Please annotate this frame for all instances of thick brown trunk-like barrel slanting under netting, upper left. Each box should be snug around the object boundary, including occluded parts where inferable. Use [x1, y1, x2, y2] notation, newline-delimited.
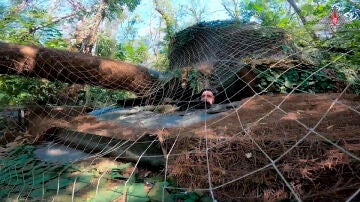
[0, 42, 158, 96]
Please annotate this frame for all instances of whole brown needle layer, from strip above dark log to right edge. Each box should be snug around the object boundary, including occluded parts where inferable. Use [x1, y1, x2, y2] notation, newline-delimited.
[5, 94, 360, 201]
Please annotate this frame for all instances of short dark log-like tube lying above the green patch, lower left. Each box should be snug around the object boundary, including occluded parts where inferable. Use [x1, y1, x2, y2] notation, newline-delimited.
[46, 127, 165, 168]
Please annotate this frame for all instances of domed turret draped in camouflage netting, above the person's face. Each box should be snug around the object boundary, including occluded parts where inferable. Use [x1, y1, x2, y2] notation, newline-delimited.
[169, 21, 301, 93]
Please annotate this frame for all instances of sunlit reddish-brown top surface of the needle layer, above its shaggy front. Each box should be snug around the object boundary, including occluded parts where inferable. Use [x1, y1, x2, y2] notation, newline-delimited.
[23, 94, 360, 138]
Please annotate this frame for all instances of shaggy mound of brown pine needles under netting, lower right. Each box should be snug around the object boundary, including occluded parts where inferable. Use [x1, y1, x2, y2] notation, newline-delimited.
[167, 94, 360, 201]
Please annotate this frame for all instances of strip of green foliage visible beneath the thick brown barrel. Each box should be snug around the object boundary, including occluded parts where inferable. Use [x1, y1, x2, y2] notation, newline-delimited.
[0, 75, 133, 107]
